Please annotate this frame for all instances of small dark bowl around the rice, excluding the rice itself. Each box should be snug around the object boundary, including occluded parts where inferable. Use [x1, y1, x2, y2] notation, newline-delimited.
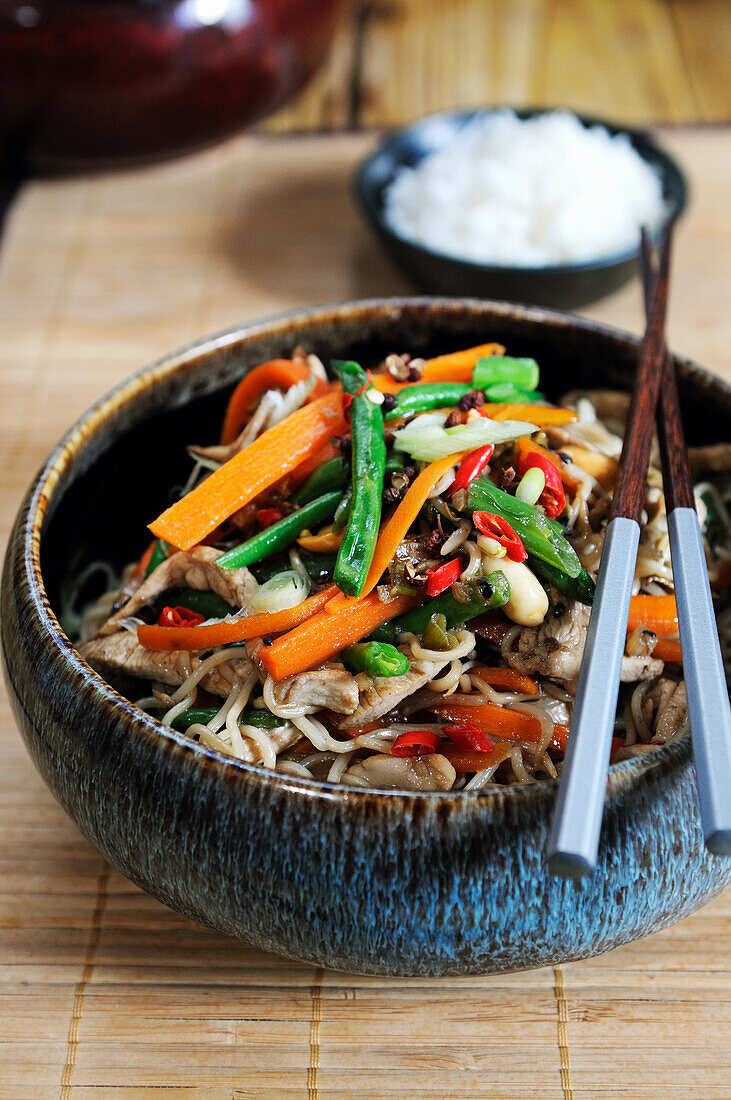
[355, 109, 688, 309]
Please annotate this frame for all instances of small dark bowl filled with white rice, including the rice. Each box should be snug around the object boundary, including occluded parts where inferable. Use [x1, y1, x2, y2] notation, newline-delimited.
[356, 108, 687, 309]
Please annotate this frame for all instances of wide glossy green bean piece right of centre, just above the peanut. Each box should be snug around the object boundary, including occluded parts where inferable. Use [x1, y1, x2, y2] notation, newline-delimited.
[467, 476, 582, 576]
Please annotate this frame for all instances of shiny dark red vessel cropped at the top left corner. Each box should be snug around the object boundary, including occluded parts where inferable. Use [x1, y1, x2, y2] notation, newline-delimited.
[0, 0, 344, 172]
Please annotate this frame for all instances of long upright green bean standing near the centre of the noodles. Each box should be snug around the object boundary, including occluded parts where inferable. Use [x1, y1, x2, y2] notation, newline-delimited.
[332, 361, 386, 596]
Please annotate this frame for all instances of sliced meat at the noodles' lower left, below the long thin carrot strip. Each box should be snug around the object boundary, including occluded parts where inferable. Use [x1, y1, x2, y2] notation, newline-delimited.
[79, 630, 251, 697]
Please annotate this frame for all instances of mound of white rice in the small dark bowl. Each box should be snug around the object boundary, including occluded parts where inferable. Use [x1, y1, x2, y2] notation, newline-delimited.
[385, 110, 665, 267]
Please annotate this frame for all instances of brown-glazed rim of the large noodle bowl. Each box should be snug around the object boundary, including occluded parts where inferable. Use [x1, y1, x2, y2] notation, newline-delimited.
[14, 297, 707, 812]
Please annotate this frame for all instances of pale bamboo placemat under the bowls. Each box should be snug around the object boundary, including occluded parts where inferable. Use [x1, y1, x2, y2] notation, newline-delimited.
[0, 130, 731, 1100]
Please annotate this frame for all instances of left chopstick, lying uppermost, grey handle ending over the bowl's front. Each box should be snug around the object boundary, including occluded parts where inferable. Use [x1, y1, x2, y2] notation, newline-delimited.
[547, 223, 673, 878]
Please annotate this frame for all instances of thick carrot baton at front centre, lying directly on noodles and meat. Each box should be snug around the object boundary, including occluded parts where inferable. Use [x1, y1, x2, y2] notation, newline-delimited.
[259, 592, 420, 680]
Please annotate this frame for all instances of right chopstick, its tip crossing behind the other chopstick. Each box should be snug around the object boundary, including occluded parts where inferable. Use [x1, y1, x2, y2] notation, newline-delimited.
[641, 230, 731, 856]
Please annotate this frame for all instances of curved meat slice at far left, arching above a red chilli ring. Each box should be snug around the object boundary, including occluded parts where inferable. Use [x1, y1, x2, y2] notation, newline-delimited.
[99, 547, 256, 636]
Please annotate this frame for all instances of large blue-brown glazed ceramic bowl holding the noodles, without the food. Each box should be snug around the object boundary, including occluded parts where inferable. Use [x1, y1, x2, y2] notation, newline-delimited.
[2, 299, 731, 975]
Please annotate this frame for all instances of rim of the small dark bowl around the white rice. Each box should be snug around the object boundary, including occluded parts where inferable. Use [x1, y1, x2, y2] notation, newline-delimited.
[353, 105, 689, 277]
